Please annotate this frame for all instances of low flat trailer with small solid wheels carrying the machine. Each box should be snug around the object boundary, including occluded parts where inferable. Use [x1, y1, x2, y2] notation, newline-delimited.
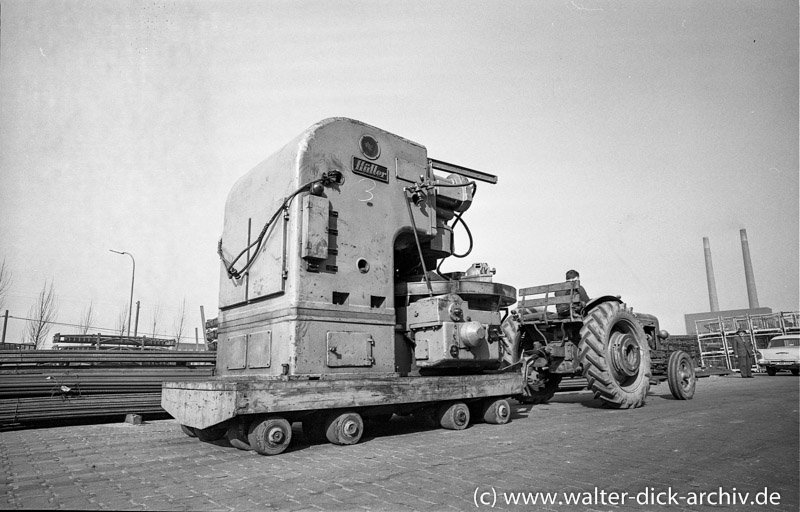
[162, 372, 523, 455]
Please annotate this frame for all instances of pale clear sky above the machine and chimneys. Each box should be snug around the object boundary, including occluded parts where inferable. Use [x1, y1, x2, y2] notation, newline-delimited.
[0, 0, 800, 341]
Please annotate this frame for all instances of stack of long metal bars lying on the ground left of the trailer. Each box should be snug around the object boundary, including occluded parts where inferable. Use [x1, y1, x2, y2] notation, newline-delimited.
[0, 350, 216, 428]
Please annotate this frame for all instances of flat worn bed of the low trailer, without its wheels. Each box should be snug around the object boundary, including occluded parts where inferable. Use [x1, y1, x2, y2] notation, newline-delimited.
[161, 368, 524, 429]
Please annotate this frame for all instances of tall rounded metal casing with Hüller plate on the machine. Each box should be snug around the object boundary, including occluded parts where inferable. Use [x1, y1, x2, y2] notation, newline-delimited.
[212, 118, 500, 376]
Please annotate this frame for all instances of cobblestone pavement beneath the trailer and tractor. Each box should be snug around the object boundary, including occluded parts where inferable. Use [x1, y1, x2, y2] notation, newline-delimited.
[0, 374, 800, 511]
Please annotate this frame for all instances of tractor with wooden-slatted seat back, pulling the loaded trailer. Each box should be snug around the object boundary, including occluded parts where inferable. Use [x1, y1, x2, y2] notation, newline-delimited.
[502, 280, 696, 409]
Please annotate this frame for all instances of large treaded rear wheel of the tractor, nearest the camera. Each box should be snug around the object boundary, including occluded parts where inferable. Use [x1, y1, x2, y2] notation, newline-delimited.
[580, 302, 652, 409]
